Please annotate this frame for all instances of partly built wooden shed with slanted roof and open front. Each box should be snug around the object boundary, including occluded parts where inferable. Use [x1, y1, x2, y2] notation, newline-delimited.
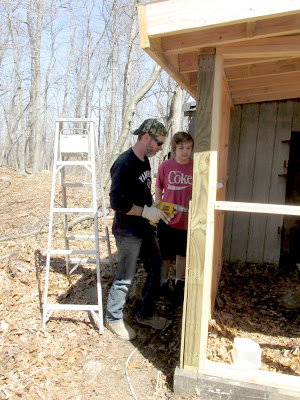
[138, 0, 300, 399]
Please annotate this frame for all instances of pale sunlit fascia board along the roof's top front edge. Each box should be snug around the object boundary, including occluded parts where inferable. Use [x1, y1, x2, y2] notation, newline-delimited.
[142, 0, 300, 36]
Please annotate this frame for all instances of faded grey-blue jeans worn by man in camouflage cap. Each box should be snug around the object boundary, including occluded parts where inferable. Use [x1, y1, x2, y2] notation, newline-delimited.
[105, 232, 162, 322]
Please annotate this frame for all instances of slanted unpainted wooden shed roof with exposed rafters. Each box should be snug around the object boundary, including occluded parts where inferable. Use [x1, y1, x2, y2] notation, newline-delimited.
[138, 0, 300, 104]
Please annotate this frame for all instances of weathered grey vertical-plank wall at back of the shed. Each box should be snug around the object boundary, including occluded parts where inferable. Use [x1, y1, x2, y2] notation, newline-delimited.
[223, 100, 300, 264]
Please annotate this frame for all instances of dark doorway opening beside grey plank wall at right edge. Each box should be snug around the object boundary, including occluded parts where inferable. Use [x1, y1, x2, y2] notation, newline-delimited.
[281, 132, 300, 265]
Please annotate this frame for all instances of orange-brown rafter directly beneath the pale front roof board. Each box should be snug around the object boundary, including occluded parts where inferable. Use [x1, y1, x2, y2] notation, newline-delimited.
[161, 14, 300, 54]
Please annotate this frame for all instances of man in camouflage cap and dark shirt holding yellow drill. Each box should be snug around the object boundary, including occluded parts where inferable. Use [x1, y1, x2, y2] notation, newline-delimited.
[105, 119, 170, 340]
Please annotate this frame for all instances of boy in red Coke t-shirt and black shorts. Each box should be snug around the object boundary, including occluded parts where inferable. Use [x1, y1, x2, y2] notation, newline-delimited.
[155, 131, 194, 303]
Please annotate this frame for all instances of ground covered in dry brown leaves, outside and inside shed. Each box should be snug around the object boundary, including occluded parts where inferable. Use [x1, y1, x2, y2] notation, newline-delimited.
[0, 167, 300, 400]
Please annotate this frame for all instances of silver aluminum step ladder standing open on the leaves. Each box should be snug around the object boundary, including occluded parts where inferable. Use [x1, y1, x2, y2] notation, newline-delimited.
[42, 118, 113, 333]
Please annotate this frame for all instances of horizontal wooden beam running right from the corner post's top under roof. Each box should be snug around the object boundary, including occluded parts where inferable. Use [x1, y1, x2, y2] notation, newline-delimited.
[217, 35, 300, 58]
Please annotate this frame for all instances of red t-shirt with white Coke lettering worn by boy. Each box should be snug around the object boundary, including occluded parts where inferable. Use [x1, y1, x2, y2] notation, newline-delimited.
[155, 158, 193, 229]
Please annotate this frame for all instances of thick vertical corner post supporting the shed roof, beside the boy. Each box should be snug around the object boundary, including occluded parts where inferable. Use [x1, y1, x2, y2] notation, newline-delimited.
[180, 54, 223, 368]
